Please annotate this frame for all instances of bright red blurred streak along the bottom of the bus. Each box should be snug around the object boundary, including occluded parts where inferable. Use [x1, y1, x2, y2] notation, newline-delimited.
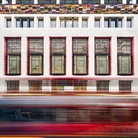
[0, 122, 138, 136]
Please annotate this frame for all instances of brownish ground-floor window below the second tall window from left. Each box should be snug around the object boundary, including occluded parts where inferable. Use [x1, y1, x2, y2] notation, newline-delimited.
[29, 81, 42, 92]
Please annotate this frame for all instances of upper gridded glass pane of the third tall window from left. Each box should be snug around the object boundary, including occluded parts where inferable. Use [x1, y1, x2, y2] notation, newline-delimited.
[51, 38, 65, 54]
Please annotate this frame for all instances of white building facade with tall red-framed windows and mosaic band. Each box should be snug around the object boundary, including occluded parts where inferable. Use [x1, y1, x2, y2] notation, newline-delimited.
[0, 0, 138, 94]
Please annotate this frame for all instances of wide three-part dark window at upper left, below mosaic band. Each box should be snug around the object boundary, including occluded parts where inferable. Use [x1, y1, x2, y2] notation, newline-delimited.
[16, 17, 34, 28]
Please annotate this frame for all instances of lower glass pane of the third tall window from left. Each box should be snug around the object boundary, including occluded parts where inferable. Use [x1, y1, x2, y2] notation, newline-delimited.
[52, 55, 65, 74]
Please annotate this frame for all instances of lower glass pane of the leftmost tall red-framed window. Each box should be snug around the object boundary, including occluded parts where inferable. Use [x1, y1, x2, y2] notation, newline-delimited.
[7, 56, 20, 74]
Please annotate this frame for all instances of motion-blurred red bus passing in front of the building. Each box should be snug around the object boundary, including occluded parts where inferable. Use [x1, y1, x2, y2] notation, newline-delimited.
[0, 96, 138, 137]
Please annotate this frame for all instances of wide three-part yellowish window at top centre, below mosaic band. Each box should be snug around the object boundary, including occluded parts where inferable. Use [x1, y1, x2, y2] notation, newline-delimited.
[60, 17, 78, 28]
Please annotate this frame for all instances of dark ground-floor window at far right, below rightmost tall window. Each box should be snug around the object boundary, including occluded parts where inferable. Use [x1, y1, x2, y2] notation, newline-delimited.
[119, 81, 132, 92]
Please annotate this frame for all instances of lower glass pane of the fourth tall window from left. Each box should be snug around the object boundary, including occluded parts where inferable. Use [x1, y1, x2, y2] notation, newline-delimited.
[73, 55, 87, 74]
